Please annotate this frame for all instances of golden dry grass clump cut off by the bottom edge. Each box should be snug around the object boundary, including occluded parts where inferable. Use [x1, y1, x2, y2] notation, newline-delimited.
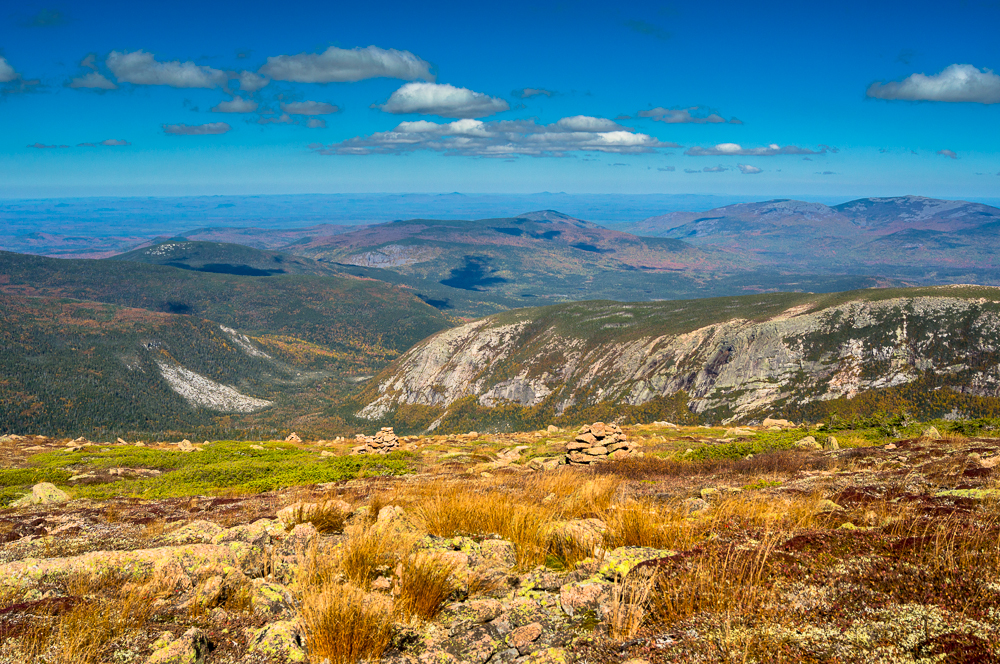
[302, 583, 393, 664]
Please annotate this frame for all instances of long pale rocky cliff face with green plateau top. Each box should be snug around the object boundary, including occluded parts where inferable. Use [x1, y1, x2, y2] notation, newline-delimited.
[358, 287, 1000, 419]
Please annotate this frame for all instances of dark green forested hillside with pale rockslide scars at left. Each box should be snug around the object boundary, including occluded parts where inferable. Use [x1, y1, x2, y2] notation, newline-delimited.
[0, 248, 452, 436]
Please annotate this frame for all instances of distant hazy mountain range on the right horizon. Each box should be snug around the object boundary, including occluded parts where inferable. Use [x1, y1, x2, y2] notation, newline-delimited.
[626, 196, 1000, 284]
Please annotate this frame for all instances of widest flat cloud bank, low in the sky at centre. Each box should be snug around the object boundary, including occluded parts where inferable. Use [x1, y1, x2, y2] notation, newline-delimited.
[317, 115, 680, 157]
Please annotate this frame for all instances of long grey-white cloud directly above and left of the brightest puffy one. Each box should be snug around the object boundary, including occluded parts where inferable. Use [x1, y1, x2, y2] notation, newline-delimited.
[258, 46, 434, 83]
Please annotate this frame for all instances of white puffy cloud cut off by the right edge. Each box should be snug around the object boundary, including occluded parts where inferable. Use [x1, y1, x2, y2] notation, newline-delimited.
[867, 65, 1000, 104]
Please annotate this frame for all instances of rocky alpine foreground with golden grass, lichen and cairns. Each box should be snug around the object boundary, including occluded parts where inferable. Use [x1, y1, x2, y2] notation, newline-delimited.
[0, 420, 1000, 664]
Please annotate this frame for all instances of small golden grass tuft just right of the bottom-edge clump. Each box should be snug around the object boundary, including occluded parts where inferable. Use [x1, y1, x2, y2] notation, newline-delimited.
[394, 552, 457, 620]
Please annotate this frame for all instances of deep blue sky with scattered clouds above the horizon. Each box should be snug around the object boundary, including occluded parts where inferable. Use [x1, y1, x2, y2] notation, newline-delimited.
[0, 0, 1000, 198]
